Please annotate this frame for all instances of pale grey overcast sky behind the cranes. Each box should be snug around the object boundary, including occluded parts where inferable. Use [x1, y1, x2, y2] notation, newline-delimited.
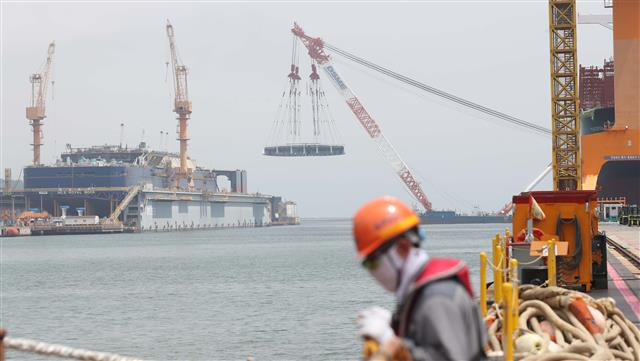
[0, 0, 613, 217]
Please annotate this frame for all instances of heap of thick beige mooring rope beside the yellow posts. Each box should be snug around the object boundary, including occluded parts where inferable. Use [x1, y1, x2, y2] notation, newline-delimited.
[485, 285, 640, 361]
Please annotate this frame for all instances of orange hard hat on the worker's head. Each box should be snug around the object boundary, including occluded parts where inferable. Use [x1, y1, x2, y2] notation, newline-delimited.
[353, 196, 420, 258]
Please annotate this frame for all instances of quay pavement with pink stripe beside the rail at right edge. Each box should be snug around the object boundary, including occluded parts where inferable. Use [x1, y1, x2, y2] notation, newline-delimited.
[591, 224, 640, 327]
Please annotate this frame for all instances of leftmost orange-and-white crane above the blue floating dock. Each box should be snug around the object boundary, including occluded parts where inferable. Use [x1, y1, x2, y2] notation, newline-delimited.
[27, 42, 56, 165]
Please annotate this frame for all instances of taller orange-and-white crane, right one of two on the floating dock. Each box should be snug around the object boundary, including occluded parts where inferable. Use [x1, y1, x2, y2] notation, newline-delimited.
[167, 20, 192, 186]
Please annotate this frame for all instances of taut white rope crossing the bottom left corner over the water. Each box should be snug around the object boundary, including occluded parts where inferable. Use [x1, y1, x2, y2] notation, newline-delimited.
[3, 337, 142, 361]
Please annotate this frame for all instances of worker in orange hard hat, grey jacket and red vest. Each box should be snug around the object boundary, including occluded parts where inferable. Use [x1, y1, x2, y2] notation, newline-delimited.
[353, 197, 486, 361]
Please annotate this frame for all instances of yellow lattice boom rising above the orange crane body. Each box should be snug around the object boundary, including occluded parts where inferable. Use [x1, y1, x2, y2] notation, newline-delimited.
[549, 0, 582, 191]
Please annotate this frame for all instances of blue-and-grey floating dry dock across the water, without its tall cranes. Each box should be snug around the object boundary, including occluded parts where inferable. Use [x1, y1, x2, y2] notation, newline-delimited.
[0, 143, 298, 234]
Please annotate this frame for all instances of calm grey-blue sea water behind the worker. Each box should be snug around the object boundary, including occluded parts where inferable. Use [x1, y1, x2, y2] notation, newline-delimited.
[0, 220, 506, 361]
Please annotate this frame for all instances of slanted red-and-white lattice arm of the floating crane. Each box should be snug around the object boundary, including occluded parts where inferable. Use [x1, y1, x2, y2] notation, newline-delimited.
[291, 24, 431, 211]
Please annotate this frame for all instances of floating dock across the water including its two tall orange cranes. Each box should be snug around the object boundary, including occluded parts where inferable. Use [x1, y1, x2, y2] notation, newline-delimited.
[0, 22, 299, 236]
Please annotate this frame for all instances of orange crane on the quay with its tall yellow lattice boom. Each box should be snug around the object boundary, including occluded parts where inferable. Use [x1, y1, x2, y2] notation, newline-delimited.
[505, 0, 607, 291]
